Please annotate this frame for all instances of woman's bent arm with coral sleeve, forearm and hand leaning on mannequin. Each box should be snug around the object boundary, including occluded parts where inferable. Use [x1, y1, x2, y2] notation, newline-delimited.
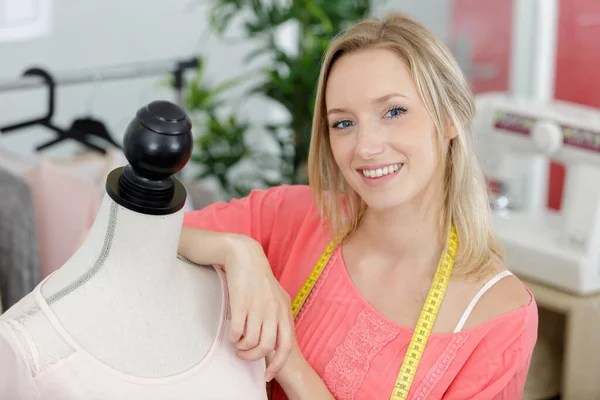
[178, 186, 312, 379]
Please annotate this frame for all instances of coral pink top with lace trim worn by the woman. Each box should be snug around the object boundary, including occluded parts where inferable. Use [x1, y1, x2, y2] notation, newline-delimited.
[184, 186, 538, 400]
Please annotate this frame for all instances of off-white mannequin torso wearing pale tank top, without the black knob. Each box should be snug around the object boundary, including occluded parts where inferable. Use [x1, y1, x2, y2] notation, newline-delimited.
[0, 196, 266, 400]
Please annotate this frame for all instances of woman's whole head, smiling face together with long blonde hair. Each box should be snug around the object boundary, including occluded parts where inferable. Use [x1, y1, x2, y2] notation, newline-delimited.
[308, 13, 503, 274]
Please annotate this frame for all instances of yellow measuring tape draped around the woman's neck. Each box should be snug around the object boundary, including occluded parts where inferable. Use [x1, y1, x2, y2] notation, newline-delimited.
[267, 224, 458, 400]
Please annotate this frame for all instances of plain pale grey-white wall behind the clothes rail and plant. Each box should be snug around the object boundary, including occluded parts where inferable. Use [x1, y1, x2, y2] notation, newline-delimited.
[0, 0, 450, 177]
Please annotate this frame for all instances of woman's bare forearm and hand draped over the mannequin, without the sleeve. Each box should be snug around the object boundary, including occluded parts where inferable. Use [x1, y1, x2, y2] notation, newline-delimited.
[178, 227, 294, 380]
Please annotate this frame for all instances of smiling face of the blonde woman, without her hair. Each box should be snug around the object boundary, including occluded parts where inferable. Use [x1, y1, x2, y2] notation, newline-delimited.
[325, 49, 442, 210]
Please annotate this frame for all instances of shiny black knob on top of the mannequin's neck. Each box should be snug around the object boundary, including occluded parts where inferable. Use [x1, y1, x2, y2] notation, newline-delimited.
[106, 101, 193, 215]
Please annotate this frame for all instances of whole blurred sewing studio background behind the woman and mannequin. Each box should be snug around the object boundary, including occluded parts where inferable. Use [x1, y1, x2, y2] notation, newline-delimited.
[0, 0, 600, 400]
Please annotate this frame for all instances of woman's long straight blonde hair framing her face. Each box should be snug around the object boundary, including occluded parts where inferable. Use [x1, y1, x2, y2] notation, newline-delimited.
[308, 13, 503, 275]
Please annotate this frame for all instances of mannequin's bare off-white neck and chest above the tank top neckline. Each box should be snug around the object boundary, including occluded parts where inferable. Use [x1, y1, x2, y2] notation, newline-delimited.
[41, 192, 223, 377]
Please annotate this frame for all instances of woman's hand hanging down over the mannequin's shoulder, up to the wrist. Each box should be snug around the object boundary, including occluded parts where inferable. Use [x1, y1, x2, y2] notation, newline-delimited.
[224, 236, 294, 381]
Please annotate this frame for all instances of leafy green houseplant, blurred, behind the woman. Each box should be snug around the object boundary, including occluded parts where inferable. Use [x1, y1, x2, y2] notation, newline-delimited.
[185, 0, 371, 199]
